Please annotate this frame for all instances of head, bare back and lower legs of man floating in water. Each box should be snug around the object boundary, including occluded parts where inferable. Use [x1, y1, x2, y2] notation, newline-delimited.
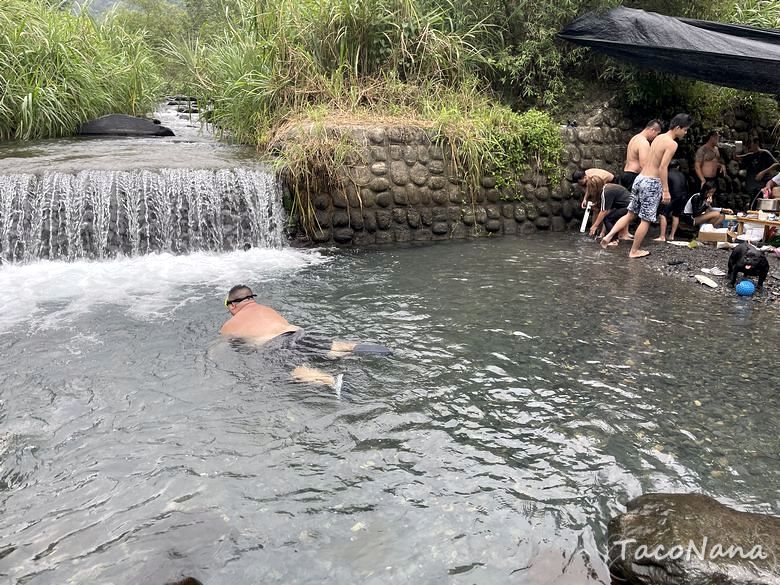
[219, 284, 391, 387]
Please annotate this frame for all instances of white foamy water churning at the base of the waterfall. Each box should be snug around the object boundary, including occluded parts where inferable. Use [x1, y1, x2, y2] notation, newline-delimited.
[0, 248, 329, 333]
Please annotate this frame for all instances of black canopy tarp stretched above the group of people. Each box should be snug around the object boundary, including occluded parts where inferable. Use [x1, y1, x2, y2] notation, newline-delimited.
[558, 7, 780, 95]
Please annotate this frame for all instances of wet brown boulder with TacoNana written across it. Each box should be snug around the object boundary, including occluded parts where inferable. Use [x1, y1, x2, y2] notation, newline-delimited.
[608, 494, 780, 585]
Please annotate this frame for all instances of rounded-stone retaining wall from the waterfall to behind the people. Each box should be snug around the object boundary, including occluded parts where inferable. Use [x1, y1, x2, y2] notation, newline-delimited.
[284, 108, 768, 246]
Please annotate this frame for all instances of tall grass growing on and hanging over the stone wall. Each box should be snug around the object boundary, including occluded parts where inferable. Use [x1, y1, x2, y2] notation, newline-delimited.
[169, 0, 562, 230]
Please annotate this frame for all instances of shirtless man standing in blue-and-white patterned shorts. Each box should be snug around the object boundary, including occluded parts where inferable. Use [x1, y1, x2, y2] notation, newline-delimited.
[601, 114, 693, 258]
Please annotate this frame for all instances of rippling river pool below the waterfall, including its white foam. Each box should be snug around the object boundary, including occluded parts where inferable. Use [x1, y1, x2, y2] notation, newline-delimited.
[0, 234, 780, 585]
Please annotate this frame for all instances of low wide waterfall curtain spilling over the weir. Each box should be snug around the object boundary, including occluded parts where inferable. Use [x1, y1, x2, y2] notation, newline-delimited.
[0, 169, 284, 262]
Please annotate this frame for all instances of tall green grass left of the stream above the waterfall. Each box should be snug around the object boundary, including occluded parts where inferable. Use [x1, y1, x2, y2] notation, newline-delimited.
[0, 0, 161, 140]
